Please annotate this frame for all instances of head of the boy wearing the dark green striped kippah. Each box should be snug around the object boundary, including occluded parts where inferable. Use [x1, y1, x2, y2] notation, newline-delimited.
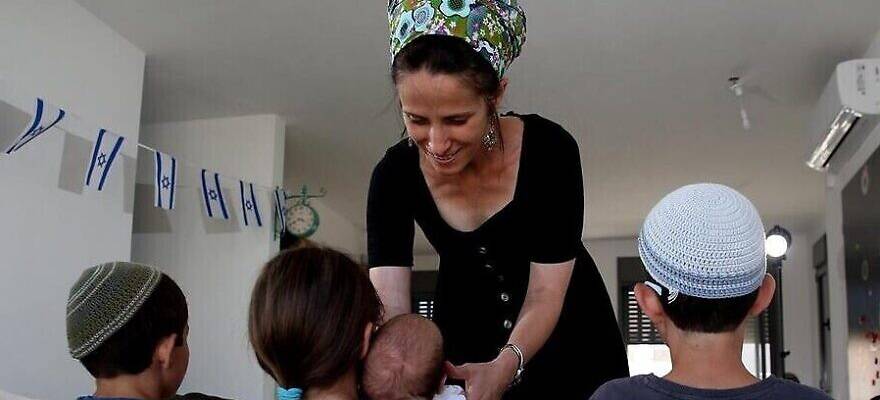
[66, 262, 189, 400]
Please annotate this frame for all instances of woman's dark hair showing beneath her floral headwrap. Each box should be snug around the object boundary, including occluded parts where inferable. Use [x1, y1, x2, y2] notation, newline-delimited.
[391, 35, 501, 99]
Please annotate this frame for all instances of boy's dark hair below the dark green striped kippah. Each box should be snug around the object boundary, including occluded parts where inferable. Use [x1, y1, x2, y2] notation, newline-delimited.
[80, 274, 189, 379]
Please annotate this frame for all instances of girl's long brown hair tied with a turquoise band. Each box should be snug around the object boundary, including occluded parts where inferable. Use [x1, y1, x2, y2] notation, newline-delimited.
[248, 246, 382, 389]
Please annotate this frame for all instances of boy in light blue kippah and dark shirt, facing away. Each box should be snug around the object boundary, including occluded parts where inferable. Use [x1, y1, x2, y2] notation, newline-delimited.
[591, 183, 830, 400]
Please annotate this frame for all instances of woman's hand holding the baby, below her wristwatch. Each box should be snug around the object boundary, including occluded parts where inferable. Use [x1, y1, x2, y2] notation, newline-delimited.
[446, 351, 519, 400]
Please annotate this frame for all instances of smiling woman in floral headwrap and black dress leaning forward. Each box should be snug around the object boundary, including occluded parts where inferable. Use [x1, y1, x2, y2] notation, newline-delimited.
[367, 0, 628, 400]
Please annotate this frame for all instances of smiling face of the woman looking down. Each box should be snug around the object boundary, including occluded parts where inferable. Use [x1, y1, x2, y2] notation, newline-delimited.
[397, 70, 489, 175]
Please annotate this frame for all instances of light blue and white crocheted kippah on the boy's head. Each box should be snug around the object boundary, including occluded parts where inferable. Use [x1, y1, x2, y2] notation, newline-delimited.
[639, 183, 767, 301]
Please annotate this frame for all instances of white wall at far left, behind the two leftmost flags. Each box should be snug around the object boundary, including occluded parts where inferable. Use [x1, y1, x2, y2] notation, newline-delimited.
[0, 0, 144, 399]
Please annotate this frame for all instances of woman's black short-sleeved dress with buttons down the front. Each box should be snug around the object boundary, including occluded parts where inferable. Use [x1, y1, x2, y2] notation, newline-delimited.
[367, 115, 628, 399]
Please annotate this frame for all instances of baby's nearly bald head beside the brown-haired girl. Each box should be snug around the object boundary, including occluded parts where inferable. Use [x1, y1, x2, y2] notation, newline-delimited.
[363, 314, 444, 400]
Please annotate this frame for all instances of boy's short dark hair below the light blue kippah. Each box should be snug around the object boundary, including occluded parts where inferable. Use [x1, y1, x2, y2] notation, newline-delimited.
[660, 290, 758, 333]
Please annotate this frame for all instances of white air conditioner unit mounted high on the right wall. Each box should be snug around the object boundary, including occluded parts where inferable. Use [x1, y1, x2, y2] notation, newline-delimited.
[807, 58, 880, 171]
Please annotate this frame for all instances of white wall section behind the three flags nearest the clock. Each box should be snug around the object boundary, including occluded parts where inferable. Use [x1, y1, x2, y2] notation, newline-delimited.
[132, 115, 284, 399]
